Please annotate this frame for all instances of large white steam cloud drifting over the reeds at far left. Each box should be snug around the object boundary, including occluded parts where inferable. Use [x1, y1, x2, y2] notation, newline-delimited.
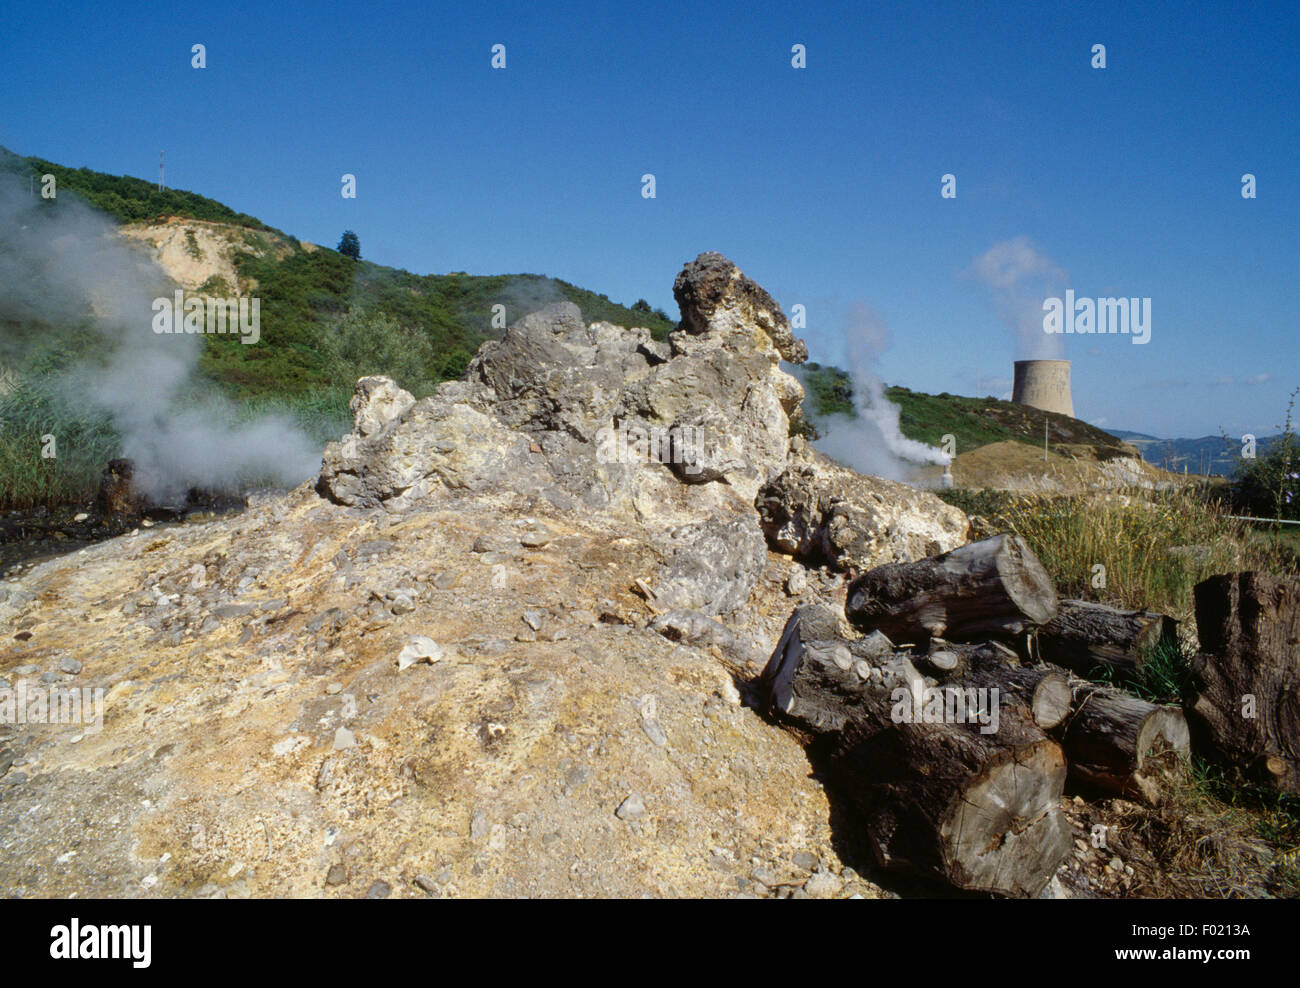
[0, 169, 320, 501]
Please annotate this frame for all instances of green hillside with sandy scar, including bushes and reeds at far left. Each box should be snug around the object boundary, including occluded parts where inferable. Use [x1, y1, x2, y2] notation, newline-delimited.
[0, 148, 675, 508]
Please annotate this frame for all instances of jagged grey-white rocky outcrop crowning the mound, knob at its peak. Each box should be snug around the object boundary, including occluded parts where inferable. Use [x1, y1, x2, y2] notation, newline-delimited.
[319, 255, 806, 511]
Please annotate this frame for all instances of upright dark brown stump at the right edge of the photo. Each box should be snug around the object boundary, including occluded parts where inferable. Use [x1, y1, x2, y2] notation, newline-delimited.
[1187, 573, 1300, 794]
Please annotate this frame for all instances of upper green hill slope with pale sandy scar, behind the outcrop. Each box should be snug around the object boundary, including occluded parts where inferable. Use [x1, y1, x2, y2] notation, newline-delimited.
[0, 148, 675, 398]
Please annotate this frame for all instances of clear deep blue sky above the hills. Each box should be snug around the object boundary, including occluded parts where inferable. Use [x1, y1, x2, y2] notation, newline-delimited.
[0, 0, 1300, 436]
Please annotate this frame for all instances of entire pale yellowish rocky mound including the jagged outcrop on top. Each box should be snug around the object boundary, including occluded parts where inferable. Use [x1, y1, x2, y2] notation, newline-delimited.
[0, 255, 1170, 898]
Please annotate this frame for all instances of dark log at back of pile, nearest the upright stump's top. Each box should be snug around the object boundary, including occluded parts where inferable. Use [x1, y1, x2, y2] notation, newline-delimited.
[1037, 601, 1178, 676]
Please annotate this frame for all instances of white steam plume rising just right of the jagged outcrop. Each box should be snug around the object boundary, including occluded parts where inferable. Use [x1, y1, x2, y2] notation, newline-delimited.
[795, 303, 950, 482]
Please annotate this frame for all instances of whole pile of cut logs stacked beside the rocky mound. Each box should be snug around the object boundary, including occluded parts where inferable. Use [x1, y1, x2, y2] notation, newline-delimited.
[762, 534, 1188, 896]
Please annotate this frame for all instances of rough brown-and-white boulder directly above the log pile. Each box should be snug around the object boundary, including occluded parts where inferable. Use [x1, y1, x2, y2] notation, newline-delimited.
[755, 439, 970, 569]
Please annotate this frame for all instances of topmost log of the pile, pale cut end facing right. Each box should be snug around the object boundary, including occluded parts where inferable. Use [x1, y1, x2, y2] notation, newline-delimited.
[845, 533, 1057, 645]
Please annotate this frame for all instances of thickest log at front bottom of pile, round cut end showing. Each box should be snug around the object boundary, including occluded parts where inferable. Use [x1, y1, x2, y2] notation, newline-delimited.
[831, 711, 1071, 896]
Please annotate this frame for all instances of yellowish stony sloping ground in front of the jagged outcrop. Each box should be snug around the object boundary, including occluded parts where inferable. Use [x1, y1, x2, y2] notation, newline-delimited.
[0, 475, 904, 896]
